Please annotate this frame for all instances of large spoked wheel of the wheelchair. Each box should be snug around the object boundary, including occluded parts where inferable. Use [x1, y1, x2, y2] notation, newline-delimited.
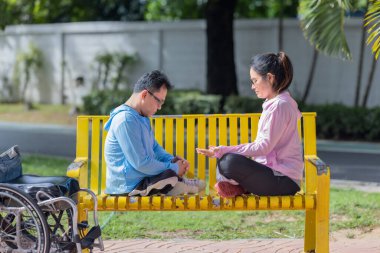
[0, 184, 50, 253]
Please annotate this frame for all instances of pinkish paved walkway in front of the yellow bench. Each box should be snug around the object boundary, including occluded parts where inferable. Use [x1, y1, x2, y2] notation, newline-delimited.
[94, 234, 380, 253]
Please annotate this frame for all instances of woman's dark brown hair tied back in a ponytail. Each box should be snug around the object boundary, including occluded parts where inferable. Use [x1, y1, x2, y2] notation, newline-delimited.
[251, 52, 293, 93]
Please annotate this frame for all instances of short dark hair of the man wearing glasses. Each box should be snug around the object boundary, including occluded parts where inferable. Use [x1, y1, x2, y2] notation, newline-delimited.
[133, 70, 173, 93]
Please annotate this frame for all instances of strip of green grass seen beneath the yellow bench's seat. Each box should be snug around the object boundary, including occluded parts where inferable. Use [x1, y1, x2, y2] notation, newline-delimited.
[101, 211, 303, 240]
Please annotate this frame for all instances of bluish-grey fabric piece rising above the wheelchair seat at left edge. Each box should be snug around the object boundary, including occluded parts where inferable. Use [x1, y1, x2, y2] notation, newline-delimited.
[0, 146, 22, 183]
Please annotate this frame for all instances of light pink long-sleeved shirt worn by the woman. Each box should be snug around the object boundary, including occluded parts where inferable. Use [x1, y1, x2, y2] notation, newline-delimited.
[215, 91, 304, 181]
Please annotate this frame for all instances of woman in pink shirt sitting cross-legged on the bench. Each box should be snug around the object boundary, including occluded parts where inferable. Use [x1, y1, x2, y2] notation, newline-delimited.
[197, 52, 304, 197]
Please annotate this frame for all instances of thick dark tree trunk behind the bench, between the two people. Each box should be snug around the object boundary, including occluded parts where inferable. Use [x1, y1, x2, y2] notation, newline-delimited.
[206, 0, 238, 97]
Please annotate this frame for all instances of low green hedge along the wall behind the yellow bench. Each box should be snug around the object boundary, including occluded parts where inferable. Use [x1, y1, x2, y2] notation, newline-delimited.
[83, 90, 380, 141]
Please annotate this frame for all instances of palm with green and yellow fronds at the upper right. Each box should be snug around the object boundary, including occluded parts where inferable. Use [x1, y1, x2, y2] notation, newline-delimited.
[300, 0, 380, 106]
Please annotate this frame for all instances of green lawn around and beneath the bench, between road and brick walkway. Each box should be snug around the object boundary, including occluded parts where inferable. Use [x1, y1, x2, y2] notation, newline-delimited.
[23, 156, 380, 240]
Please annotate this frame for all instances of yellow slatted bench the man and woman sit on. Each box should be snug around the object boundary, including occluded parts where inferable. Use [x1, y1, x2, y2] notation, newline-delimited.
[67, 113, 330, 253]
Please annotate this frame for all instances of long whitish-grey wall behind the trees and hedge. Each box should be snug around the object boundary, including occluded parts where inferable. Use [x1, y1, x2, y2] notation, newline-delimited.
[0, 19, 380, 106]
